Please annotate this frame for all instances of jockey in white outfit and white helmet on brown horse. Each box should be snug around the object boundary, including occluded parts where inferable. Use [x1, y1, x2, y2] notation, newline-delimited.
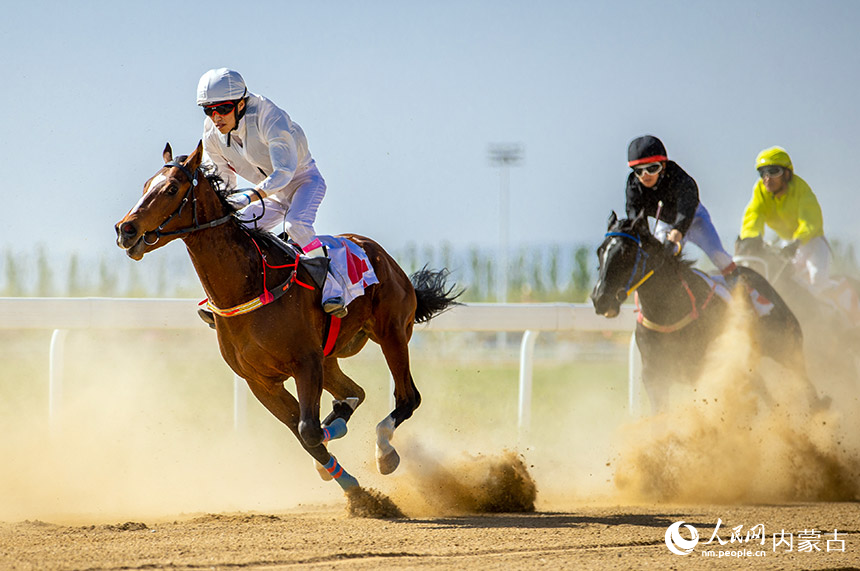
[197, 68, 347, 317]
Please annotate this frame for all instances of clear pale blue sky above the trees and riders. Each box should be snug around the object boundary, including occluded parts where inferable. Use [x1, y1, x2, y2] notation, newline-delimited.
[0, 0, 860, 264]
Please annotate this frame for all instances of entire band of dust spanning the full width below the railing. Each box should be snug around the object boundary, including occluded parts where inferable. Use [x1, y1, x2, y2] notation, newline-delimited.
[0, 290, 860, 524]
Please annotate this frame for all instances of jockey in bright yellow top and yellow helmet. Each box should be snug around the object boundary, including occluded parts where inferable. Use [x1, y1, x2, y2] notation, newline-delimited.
[740, 147, 831, 291]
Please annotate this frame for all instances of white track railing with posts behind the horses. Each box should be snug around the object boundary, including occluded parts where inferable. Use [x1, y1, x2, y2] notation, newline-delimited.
[0, 298, 639, 434]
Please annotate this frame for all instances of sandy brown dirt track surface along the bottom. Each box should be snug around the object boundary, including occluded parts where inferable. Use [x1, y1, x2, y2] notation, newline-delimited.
[0, 503, 860, 571]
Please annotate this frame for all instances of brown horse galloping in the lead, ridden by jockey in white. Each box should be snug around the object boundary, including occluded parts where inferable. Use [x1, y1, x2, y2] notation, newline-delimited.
[116, 143, 458, 490]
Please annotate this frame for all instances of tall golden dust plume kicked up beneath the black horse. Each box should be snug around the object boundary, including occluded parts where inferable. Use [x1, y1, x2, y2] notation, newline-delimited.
[615, 290, 860, 504]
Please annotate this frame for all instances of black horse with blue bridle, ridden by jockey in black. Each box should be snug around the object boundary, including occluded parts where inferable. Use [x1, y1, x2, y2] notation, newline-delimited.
[591, 212, 818, 412]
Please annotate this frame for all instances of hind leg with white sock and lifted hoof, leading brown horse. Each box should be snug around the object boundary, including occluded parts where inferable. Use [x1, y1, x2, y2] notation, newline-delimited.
[376, 323, 421, 474]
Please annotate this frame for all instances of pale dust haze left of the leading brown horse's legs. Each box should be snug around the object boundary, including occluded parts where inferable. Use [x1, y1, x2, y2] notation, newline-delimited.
[0, 330, 343, 524]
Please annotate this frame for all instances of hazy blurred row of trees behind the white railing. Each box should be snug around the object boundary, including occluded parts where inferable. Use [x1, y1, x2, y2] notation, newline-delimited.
[0, 242, 596, 302]
